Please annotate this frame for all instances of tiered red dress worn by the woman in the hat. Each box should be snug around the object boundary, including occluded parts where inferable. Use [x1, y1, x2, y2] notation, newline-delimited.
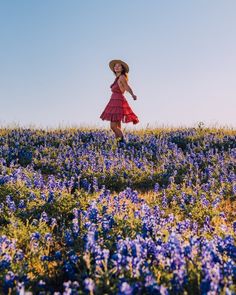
[100, 77, 139, 124]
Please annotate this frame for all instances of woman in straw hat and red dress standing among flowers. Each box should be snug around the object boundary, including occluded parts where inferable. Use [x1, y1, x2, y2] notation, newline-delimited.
[100, 59, 139, 143]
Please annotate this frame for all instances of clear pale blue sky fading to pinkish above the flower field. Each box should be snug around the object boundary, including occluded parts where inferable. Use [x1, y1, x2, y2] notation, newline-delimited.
[0, 0, 236, 128]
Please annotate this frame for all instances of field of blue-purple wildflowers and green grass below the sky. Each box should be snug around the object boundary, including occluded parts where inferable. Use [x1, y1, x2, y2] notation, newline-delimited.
[0, 126, 236, 295]
